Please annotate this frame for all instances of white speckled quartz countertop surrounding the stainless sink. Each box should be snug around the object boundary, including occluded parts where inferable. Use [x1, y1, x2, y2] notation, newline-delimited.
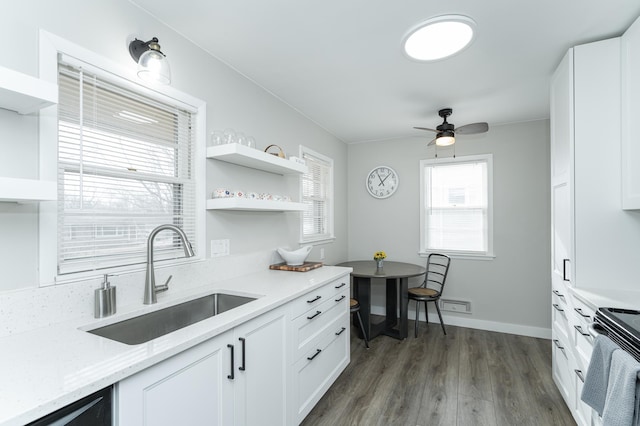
[0, 266, 351, 425]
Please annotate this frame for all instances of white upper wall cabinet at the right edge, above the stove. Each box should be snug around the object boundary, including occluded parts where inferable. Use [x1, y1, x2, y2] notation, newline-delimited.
[620, 18, 640, 210]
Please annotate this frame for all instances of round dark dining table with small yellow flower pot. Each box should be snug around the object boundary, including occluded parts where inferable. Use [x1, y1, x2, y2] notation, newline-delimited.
[336, 260, 426, 339]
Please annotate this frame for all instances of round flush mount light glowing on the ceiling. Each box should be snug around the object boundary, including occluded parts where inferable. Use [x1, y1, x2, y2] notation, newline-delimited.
[403, 15, 476, 61]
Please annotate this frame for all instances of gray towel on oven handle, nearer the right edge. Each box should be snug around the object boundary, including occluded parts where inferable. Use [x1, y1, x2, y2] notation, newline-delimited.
[602, 350, 640, 425]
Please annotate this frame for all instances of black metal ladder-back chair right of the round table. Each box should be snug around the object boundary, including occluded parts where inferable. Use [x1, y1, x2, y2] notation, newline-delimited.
[409, 253, 451, 337]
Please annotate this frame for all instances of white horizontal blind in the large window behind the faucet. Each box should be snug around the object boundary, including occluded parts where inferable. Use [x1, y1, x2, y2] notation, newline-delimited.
[57, 62, 197, 275]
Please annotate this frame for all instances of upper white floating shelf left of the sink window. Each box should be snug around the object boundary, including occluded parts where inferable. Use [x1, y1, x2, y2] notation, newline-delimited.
[0, 67, 58, 114]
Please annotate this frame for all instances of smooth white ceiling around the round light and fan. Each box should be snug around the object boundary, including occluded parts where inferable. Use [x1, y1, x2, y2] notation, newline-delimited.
[132, 0, 640, 143]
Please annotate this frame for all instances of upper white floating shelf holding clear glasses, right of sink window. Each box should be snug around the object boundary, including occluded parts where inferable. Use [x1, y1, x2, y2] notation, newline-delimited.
[207, 143, 307, 175]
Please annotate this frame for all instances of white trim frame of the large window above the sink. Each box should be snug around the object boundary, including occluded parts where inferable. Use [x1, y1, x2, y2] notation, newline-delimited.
[38, 30, 206, 287]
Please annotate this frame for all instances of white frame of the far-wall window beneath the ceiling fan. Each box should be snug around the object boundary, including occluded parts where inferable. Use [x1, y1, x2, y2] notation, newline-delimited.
[418, 154, 495, 260]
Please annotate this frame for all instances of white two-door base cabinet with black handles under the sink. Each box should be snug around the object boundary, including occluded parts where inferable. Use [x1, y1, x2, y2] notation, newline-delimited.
[118, 308, 287, 426]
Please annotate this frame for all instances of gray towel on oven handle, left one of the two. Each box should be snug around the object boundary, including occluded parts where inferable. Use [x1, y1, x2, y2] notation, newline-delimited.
[580, 334, 620, 415]
